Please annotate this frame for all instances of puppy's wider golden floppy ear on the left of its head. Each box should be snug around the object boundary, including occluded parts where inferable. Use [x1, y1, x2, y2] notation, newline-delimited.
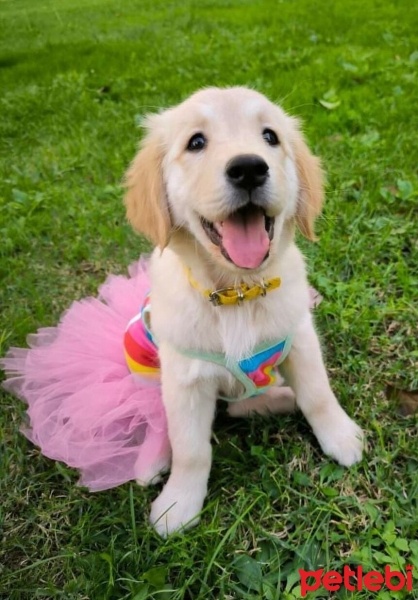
[125, 115, 171, 248]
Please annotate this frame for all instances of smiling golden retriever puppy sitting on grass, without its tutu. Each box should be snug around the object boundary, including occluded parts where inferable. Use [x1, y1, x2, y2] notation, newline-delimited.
[126, 87, 363, 536]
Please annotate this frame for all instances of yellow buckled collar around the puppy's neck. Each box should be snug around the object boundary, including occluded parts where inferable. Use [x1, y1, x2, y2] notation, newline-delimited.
[185, 267, 281, 306]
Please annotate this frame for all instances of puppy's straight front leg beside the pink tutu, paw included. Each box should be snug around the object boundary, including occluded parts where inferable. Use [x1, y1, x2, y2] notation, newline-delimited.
[150, 348, 217, 537]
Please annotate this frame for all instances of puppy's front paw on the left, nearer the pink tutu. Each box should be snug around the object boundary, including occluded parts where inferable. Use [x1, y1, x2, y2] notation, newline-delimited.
[150, 481, 206, 537]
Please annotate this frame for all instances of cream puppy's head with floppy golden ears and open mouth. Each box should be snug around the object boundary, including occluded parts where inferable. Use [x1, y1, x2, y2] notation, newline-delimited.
[126, 88, 323, 270]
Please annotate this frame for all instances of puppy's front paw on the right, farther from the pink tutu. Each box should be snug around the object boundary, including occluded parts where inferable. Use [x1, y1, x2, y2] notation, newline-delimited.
[313, 407, 364, 467]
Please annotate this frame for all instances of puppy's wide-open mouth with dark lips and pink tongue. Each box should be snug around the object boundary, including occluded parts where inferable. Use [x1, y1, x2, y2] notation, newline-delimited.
[200, 202, 274, 269]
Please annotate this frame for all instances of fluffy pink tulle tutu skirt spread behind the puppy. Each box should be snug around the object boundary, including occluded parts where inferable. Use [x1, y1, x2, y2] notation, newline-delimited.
[0, 259, 169, 491]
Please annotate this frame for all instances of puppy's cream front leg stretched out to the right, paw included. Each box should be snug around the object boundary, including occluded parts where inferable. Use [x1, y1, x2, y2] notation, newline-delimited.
[283, 315, 363, 466]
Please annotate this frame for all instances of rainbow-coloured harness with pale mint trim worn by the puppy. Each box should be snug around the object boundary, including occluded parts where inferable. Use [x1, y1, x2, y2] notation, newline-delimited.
[124, 295, 292, 402]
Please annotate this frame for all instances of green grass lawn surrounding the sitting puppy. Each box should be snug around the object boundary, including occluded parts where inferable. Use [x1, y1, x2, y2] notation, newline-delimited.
[0, 0, 418, 600]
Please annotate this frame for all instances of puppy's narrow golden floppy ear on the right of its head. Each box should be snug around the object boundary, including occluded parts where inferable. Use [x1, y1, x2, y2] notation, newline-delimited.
[292, 119, 324, 241]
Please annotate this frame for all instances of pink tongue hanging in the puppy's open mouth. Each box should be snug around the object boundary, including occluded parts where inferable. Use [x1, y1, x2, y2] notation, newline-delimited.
[222, 210, 270, 269]
